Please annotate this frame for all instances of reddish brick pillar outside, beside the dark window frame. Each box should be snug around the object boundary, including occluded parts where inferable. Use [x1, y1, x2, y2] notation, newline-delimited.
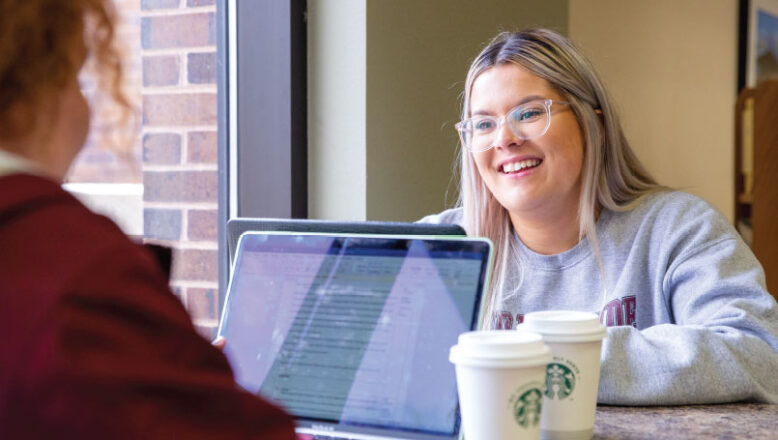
[139, 0, 218, 338]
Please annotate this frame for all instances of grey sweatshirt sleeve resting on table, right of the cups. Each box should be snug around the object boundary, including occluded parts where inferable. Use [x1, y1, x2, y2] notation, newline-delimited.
[598, 236, 778, 405]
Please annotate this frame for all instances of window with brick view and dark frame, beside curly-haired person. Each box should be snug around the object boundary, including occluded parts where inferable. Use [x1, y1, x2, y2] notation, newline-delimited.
[64, 0, 307, 338]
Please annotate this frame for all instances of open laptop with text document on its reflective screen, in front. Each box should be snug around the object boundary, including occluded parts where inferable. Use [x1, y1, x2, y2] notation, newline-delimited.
[219, 232, 491, 440]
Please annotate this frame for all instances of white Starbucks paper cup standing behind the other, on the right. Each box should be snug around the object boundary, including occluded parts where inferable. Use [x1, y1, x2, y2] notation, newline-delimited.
[517, 311, 607, 440]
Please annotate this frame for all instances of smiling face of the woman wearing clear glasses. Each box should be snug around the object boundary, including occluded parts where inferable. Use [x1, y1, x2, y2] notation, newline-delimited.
[470, 64, 583, 220]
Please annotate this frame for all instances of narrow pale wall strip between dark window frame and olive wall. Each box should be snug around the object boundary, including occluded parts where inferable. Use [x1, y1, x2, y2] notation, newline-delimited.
[307, 0, 367, 220]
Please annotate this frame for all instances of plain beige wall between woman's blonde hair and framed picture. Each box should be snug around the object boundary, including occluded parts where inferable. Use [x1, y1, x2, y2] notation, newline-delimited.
[569, 0, 738, 220]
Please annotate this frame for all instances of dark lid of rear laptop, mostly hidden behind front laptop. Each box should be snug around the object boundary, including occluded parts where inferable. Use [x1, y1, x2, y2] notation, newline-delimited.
[227, 217, 467, 263]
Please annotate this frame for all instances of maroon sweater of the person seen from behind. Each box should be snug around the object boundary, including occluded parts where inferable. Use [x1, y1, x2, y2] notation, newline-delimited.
[0, 174, 294, 439]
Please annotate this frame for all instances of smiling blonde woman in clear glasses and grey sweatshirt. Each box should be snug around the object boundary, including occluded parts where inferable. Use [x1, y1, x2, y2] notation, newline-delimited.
[423, 30, 778, 405]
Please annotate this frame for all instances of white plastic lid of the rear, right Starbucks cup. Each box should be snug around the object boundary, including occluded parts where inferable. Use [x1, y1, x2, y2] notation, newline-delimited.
[517, 310, 607, 342]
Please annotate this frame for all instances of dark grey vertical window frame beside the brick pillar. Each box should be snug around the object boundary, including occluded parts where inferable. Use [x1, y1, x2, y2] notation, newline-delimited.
[216, 0, 308, 308]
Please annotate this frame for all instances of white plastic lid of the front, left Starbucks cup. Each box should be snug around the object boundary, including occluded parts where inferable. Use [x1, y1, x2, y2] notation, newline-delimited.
[449, 330, 551, 367]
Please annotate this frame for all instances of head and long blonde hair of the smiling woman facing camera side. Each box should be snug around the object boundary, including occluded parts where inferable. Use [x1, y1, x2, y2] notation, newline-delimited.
[452, 30, 661, 296]
